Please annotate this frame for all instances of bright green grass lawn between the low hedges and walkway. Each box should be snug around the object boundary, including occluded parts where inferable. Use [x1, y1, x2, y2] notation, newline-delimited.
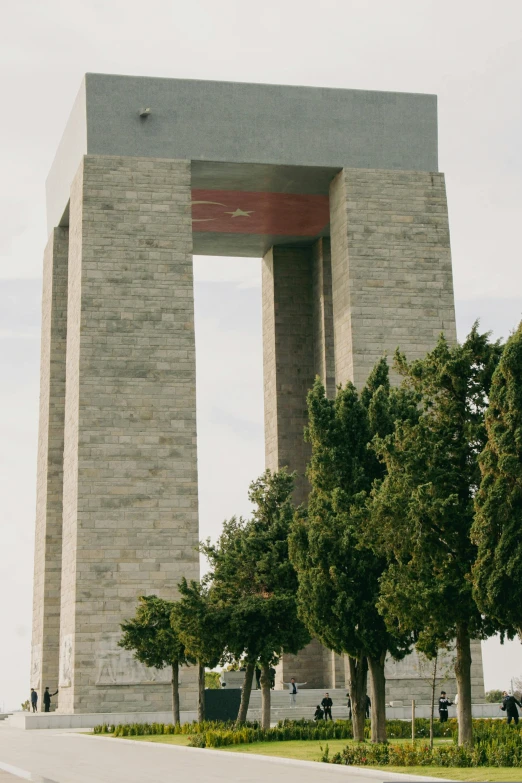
[116, 734, 522, 783]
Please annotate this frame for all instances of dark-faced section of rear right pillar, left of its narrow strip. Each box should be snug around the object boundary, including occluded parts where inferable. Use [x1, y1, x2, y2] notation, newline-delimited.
[262, 247, 314, 503]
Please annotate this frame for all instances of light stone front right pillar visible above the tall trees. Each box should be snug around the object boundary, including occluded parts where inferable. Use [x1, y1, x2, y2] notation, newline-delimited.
[330, 169, 456, 387]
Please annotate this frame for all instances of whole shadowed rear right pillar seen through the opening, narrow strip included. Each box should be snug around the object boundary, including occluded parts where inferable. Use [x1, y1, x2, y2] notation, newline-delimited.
[262, 240, 334, 688]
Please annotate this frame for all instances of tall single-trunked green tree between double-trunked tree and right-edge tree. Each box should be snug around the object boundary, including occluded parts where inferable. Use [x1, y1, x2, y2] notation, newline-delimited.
[370, 325, 501, 744]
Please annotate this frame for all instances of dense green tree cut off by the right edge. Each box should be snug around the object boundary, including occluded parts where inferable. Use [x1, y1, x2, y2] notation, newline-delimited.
[472, 323, 522, 641]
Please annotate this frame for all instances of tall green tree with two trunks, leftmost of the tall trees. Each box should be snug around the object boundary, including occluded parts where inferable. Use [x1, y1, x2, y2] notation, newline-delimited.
[290, 359, 414, 742]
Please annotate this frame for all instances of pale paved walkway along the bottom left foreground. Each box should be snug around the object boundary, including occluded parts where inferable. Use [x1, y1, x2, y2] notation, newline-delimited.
[0, 725, 446, 783]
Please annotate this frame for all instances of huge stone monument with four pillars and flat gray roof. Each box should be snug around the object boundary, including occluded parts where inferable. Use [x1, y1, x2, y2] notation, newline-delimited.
[31, 74, 482, 713]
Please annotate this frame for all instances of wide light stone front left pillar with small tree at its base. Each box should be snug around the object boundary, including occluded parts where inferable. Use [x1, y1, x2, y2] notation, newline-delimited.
[59, 156, 199, 712]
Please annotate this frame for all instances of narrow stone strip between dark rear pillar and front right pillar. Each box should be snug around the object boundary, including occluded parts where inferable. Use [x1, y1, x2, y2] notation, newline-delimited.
[312, 237, 335, 398]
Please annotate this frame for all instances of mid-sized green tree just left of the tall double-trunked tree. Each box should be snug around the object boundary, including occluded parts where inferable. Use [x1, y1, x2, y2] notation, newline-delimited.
[202, 470, 310, 728]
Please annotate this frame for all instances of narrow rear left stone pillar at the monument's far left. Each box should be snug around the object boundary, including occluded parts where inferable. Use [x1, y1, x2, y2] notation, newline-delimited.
[31, 228, 69, 692]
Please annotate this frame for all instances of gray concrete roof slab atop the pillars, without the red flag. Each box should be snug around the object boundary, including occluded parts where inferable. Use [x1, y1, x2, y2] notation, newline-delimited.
[47, 74, 438, 255]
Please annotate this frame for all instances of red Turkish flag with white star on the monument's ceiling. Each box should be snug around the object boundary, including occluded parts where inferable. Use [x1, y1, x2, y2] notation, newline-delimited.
[192, 190, 330, 237]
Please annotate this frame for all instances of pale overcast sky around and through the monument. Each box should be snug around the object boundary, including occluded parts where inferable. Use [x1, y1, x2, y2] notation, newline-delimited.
[0, 0, 522, 709]
